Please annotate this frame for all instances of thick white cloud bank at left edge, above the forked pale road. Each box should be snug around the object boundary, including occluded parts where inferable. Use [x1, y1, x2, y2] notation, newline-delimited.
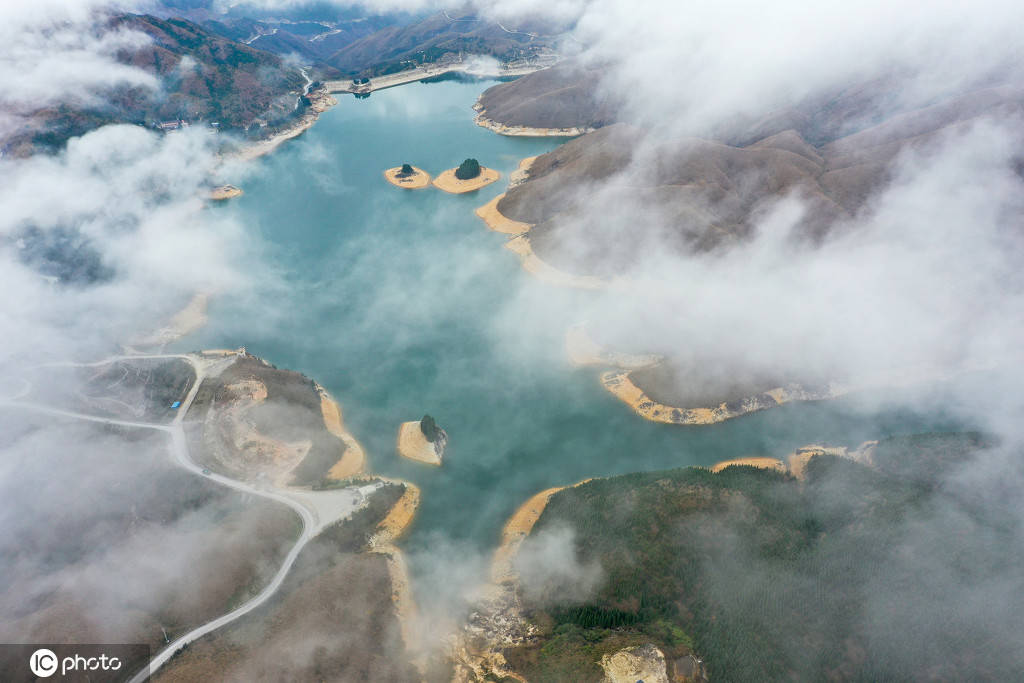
[0, 126, 256, 368]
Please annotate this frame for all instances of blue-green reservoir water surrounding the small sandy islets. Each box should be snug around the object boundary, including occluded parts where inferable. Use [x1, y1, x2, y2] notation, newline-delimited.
[176, 81, 950, 577]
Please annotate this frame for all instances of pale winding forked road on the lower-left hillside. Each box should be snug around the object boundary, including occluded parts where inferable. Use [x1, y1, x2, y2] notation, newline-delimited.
[0, 354, 379, 683]
